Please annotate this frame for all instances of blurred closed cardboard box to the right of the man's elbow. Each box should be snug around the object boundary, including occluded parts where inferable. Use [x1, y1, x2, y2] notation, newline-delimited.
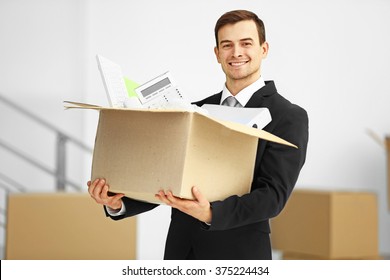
[271, 189, 379, 259]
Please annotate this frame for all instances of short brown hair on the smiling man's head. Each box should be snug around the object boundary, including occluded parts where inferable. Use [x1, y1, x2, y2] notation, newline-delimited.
[214, 10, 265, 47]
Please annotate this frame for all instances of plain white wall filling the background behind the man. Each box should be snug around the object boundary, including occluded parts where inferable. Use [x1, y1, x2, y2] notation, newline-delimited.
[0, 0, 390, 259]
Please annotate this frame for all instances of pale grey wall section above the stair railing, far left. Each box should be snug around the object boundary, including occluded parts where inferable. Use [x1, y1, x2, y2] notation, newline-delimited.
[0, 0, 86, 190]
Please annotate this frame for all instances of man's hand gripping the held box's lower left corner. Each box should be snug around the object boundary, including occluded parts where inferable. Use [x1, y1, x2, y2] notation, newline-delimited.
[87, 179, 125, 210]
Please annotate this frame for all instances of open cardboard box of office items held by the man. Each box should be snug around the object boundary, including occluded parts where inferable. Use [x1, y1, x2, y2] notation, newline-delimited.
[64, 103, 296, 203]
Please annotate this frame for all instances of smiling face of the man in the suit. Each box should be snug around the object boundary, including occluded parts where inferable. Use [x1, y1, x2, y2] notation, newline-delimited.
[214, 20, 268, 86]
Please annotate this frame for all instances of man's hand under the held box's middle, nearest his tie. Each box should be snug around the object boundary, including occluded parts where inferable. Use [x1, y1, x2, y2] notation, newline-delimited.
[156, 187, 212, 224]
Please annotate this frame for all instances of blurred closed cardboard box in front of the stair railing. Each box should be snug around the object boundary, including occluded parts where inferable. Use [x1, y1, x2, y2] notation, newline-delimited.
[5, 193, 136, 260]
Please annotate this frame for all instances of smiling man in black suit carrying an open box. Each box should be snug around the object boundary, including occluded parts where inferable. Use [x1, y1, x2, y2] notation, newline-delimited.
[88, 10, 308, 259]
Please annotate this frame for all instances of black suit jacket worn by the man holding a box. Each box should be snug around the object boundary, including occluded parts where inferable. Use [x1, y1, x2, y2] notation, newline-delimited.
[106, 81, 308, 259]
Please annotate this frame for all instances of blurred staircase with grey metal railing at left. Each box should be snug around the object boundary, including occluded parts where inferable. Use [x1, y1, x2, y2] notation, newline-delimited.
[0, 93, 92, 259]
